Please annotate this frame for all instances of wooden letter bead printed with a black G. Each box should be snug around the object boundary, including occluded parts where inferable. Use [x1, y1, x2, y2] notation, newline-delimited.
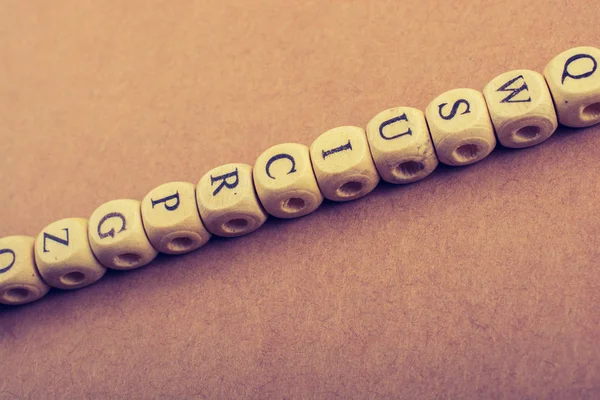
[88, 199, 157, 270]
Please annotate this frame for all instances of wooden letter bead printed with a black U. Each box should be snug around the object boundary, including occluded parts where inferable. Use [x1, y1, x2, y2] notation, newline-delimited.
[367, 107, 438, 183]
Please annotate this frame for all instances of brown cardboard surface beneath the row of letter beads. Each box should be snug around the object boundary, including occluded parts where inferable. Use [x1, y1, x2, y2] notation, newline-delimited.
[0, 0, 600, 400]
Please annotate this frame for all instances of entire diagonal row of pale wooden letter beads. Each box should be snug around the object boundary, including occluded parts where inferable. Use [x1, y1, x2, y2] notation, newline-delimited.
[0, 47, 600, 304]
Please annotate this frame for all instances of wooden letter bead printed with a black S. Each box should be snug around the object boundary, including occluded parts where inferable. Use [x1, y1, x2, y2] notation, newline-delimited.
[425, 89, 496, 166]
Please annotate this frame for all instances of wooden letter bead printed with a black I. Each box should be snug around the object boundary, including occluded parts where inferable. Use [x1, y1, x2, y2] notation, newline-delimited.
[310, 126, 379, 201]
